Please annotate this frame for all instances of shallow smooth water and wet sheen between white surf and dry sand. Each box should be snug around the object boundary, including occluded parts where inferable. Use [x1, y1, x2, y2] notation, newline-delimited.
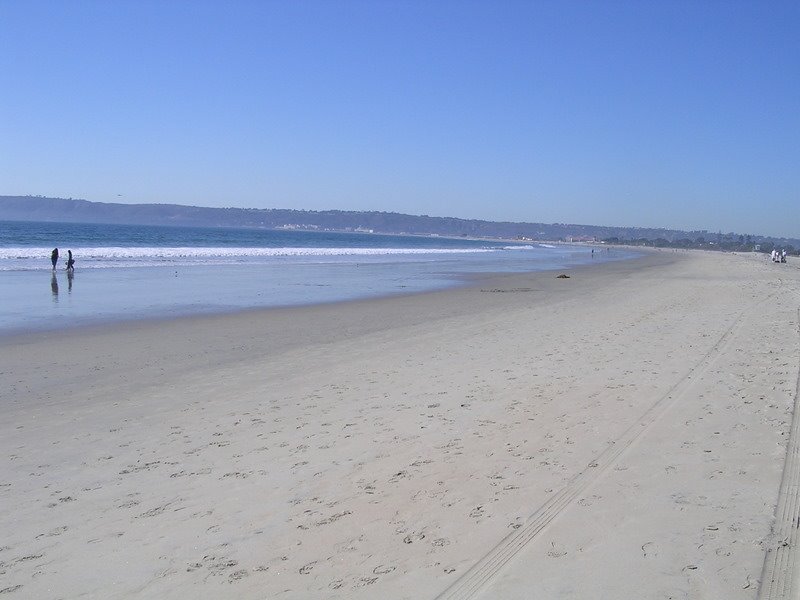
[0, 243, 631, 336]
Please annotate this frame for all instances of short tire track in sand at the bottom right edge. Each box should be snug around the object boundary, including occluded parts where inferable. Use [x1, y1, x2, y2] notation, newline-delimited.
[758, 309, 800, 600]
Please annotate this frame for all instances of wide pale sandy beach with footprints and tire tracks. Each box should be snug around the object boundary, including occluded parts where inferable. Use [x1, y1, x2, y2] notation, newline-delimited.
[0, 251, 800, 599]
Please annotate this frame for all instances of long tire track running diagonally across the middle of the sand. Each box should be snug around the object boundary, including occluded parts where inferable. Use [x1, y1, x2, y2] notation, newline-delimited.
[436, 294, 764, 600]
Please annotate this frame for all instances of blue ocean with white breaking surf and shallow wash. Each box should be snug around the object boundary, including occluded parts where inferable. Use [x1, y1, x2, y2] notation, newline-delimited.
[0, 222, 636, 334]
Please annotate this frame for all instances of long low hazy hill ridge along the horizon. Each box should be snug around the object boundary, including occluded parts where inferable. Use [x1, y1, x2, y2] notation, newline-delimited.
[0, 196, 800, 251]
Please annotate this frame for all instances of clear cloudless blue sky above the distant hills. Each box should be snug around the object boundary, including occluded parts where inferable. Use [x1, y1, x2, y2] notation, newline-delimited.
[0, 0, 800, 237]
